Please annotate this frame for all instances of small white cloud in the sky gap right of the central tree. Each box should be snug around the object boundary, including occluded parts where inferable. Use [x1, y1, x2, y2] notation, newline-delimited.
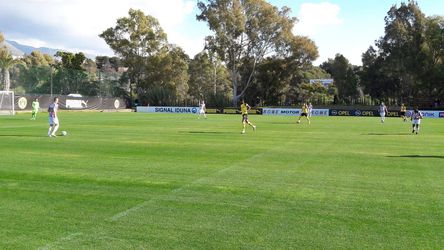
[294, 2, 342, 36]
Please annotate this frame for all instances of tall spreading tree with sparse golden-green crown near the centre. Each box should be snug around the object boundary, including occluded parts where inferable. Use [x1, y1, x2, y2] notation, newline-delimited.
[197, 0, 296, 104]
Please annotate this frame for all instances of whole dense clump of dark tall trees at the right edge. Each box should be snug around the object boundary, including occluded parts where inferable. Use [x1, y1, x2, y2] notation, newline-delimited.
[360, 1, 444, 105]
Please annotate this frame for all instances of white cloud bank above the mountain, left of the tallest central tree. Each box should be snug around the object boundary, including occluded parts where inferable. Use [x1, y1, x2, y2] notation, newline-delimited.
[0, 0, 195, 54]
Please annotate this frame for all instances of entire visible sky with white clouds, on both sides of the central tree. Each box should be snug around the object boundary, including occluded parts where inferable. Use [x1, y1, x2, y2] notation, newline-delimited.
[0, 0, 444, 65]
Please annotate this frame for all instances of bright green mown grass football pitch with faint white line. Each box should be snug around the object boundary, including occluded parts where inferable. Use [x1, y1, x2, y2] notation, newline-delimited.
[0, 111, 444, 249]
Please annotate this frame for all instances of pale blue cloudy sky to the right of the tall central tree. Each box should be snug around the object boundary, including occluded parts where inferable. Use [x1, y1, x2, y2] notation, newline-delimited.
[269, 0, 444, 65]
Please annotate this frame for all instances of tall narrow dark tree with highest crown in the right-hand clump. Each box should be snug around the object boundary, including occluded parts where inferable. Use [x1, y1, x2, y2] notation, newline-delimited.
[376, 0, 426, 99]
